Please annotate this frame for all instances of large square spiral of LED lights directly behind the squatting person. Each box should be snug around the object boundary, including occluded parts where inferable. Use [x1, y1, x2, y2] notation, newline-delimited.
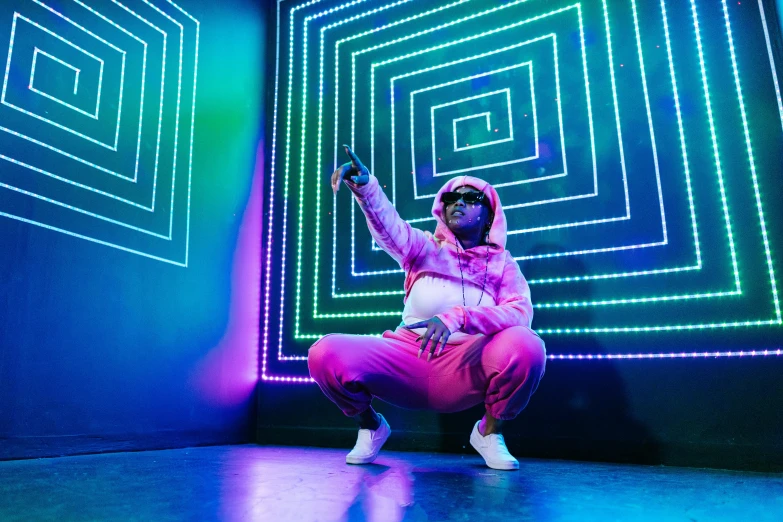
[262, 0, 783, 381]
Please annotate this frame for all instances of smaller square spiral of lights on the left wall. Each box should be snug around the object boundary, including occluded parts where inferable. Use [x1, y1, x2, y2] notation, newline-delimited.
[0, 0, 199, 266]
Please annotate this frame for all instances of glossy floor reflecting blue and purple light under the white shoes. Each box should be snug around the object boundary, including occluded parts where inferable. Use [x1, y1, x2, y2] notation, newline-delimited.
[0, 446, 783, 522]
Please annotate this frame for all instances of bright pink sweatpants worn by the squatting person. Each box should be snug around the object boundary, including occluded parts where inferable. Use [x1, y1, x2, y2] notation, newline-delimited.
[307, 326, 546, 420]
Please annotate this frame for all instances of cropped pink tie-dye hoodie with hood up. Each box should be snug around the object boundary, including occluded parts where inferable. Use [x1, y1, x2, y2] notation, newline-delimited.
[345, 175, 533, 335]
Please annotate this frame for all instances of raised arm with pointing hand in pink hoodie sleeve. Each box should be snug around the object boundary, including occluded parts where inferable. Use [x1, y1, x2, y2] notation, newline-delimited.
[332, 146, 427, 271]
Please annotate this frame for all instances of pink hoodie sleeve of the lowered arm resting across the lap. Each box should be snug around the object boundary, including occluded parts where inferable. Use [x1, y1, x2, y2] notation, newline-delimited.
[436, 251, 533, 335]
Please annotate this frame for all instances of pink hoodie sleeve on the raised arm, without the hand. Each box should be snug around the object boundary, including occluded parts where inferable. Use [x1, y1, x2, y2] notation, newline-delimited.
[343, 175, 427, 271]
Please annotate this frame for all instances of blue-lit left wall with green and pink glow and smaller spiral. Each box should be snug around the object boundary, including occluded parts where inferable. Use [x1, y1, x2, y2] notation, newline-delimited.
[0, 0, 267, 448]
